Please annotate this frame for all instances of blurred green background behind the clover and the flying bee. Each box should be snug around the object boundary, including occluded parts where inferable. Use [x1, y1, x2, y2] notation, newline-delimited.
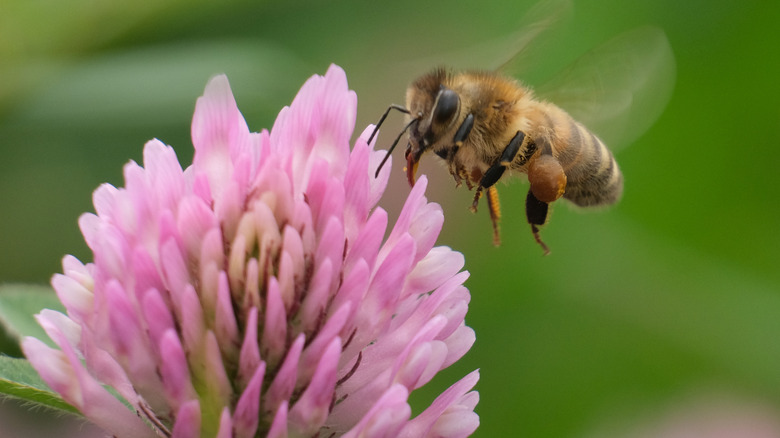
[0, 0, 780, 437]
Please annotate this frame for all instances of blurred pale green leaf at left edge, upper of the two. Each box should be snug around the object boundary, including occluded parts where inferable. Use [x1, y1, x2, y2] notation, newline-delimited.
[0, 284, 65, 346]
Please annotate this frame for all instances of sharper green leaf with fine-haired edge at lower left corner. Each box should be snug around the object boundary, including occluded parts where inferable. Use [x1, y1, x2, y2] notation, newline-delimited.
[0, 356, 79, 414]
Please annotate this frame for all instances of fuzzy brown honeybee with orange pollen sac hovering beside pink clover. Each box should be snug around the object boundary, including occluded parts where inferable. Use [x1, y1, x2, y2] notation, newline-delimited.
[369, 0, 674, 254]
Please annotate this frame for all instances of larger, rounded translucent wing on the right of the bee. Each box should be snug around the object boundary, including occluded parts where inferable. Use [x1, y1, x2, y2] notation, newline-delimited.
[536, 27, 675, 150]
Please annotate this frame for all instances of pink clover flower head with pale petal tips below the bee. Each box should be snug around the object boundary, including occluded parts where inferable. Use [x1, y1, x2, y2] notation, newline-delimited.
[23, 66, 479, 437]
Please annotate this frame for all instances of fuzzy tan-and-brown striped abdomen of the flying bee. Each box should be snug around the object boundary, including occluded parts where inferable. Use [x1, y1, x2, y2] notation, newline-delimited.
[553, 116, 623, 207]
